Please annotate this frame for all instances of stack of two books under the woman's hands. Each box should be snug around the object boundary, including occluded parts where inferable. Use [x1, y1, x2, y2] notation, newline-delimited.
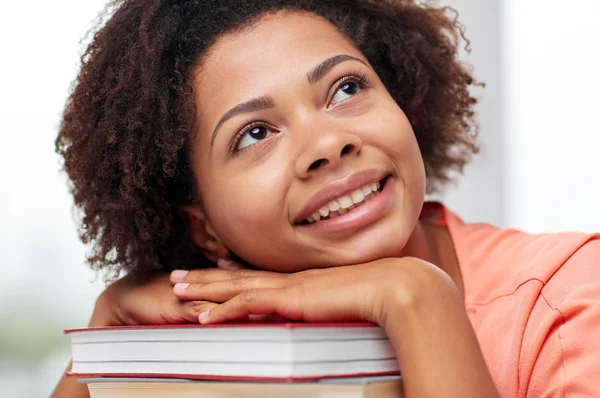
[66, 322, 402, 398]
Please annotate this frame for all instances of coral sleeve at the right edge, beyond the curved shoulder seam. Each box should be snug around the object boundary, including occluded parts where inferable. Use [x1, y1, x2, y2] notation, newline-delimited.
[521, 238, 600, 397]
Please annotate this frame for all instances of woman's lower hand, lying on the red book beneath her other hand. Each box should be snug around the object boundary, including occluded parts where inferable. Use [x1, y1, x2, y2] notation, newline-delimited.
[90, 275, 214, 326]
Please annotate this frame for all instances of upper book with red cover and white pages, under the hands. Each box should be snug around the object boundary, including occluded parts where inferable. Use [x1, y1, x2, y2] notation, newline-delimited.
[65, 322, 399, 382]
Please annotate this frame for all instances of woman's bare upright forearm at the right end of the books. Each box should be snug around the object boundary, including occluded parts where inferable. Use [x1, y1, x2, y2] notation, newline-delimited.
[383, 262, 498, 398]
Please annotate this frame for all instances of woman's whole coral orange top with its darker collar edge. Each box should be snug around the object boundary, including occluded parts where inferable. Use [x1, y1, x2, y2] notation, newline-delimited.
[423, 203, 600, 397]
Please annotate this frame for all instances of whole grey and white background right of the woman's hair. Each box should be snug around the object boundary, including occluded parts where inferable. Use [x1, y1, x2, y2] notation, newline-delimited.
[442, 0, 600, 232]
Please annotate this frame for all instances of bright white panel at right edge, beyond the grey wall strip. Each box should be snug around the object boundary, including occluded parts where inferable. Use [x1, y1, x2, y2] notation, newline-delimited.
[502, 0, 600, 232]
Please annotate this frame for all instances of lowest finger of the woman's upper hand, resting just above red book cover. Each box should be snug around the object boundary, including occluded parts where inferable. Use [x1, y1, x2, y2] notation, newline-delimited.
[199, 289, 294, 324]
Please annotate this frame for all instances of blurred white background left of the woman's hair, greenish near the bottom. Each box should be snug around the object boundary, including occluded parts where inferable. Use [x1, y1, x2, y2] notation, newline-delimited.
[0, 0, 105, 398]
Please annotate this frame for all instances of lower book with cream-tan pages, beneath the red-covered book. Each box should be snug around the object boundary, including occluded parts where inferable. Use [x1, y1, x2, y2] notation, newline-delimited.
[80, 376, 403, 398]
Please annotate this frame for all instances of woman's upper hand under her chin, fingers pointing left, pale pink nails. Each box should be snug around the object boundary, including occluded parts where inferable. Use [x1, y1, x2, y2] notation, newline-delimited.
[171, 258, 452, 325]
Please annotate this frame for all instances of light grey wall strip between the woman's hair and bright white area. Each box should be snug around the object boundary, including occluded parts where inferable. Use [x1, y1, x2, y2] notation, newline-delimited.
[442, 0, 507, 226]
